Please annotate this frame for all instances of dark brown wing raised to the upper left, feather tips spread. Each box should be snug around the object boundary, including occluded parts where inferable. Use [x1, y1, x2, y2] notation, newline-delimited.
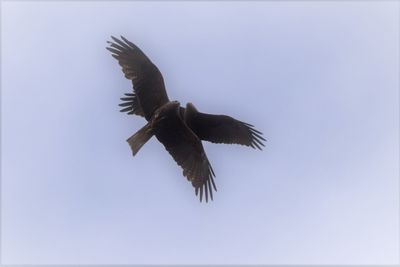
[107, 36, 169, 120]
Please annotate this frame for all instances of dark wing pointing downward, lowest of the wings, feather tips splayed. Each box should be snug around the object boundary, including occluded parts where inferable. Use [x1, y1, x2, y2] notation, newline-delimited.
[153, 108, 217, 201]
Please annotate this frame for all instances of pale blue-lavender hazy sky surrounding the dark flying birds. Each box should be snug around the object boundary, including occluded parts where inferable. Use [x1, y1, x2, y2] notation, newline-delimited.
[1, 1, 399, 264]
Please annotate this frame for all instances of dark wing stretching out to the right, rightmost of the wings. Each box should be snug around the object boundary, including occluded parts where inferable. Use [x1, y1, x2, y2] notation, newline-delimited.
[185, 103, 266, 150]
